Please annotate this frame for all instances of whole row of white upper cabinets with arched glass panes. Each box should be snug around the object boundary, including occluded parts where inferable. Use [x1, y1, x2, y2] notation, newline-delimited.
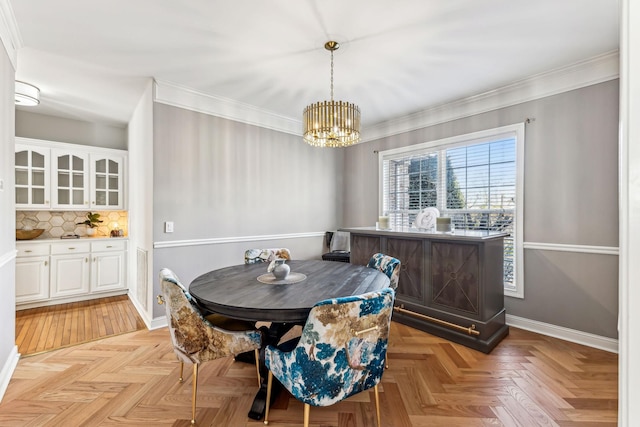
[15, 137, 127, 210]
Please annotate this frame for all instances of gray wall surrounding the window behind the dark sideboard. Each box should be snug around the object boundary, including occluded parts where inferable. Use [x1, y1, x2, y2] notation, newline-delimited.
[344, 80, 619, 338]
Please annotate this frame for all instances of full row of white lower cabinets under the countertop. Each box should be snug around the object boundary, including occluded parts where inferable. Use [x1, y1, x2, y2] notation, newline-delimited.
[16, 238, 127, 308]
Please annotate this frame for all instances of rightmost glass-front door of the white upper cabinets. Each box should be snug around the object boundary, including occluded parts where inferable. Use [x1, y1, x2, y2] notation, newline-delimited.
[91, 154, 124, 209]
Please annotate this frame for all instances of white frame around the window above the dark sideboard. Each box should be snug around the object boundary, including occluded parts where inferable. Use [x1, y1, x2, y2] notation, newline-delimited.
[378, 123, 525, 298]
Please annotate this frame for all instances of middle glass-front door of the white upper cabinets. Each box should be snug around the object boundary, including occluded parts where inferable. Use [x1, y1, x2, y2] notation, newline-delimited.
[52, 150, 89, 209]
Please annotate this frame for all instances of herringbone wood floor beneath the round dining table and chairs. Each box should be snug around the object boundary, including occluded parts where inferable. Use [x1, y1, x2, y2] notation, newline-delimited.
[0, 322, 618, 427]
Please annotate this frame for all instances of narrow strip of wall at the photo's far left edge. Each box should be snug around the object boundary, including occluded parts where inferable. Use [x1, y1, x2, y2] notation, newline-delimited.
[0, 38, 16, 386]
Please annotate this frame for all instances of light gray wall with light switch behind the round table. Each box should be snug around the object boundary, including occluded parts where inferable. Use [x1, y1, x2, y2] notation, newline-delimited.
[153, 103, 343, 316]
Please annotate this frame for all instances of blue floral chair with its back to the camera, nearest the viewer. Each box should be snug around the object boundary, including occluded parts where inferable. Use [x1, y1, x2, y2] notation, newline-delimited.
[264, 288, 395, 427]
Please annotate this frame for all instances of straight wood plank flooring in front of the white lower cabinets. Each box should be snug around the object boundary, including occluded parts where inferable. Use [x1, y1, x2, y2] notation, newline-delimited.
[16, 295, 145, 356]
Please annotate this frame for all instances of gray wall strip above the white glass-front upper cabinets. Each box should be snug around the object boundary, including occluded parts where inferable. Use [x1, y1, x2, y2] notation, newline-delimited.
[15, 107, 127, 150]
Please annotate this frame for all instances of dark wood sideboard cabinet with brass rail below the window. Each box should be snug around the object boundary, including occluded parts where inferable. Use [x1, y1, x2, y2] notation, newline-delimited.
[342, 227, 509, 353]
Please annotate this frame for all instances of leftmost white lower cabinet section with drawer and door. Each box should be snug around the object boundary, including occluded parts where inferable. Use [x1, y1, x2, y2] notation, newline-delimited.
[16, 244, 49, 304]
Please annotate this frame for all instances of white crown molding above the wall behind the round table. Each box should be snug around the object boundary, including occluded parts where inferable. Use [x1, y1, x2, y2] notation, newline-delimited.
[153, 80, 302, 135]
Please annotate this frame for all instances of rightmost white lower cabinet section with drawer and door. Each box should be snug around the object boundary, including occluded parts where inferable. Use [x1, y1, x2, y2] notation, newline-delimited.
[91, 240, 126, 292]
